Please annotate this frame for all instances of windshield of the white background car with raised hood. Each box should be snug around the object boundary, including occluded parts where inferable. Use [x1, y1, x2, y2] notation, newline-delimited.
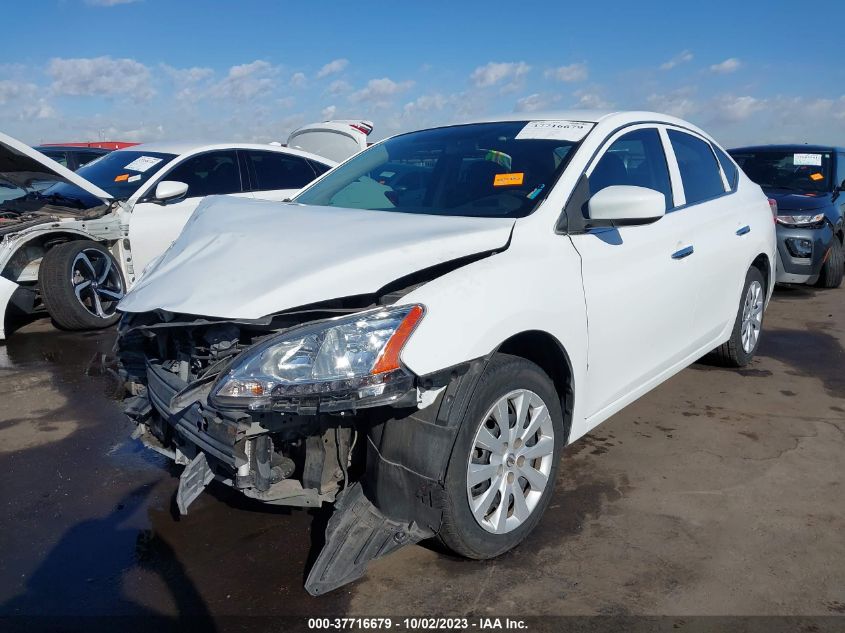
[42, 150, 176, 204]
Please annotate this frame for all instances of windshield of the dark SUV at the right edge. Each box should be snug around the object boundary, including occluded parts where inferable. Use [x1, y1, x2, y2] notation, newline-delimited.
[731, 147, 833, 193]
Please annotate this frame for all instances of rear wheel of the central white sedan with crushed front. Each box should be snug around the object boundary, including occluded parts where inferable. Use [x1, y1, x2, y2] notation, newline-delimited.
[711, 267, 766, 367]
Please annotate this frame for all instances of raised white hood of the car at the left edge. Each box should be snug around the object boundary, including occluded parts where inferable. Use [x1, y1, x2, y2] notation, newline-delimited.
[0, 132, 112, 204]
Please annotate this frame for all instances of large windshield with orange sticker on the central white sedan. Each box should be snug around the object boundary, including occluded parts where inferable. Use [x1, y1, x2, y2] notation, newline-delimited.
[294, 121, 584, 218]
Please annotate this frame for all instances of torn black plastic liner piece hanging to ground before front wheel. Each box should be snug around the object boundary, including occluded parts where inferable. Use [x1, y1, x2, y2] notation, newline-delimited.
[305, 483, 434, 596]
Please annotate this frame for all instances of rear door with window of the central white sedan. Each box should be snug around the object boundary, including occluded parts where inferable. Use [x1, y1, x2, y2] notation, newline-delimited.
[667, 127, 753, 347]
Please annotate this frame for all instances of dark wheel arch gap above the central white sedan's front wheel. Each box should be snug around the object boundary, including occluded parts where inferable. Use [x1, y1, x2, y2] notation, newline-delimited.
[495, 330, 575, 444]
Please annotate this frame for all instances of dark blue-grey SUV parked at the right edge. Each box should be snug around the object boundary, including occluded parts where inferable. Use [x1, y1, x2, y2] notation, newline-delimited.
[729, 145, 845, 288]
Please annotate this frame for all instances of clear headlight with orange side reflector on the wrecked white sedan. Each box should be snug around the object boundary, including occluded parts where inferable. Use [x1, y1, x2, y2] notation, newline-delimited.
[210, 305, 424, 413]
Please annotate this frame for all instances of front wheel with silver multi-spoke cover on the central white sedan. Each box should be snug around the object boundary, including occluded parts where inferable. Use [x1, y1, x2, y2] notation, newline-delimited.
[438, 354, 565, 559]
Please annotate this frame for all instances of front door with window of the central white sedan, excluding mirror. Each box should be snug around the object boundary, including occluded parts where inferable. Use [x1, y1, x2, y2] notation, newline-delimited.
[571, 125, 696, 426]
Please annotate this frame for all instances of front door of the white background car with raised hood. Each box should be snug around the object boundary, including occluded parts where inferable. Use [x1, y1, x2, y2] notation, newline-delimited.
[129, 150, 251, 279]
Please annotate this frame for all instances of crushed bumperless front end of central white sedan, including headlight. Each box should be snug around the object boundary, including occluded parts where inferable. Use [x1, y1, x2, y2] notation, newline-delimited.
[118, 300, 485, 595]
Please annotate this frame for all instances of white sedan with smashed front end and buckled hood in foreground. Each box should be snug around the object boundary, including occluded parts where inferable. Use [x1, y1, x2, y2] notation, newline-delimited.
[119, 112, 775, 594]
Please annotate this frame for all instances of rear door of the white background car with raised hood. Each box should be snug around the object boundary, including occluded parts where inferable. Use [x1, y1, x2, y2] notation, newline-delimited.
[240, 149, 324, 200]
